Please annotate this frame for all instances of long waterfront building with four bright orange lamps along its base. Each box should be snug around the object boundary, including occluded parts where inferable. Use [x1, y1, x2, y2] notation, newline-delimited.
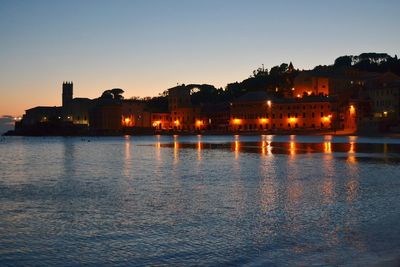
[230, 92, 336, 131]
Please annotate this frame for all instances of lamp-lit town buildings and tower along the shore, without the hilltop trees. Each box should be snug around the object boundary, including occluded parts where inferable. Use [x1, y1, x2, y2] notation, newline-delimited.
[16, 68, 400, 134]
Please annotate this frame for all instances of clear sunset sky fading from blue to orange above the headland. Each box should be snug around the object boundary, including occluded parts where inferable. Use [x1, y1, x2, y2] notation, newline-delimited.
[0, 0, 400, 117]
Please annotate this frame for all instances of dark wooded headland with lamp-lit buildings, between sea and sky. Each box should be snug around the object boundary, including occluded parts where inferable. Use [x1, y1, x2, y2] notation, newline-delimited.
[6, 53, 400, 136]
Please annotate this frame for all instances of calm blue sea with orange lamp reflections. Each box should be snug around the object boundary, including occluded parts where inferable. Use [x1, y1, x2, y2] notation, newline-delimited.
[0, 136, 400, 266]
